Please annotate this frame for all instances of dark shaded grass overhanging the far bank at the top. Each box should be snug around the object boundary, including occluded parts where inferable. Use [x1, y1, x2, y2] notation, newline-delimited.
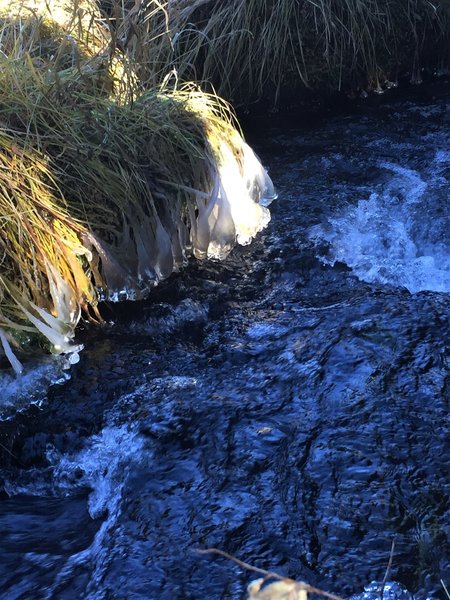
[113, 0, 450, 105]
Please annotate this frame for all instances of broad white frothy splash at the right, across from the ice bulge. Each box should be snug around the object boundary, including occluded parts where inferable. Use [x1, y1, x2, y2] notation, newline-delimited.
[310, 162, 450, 293]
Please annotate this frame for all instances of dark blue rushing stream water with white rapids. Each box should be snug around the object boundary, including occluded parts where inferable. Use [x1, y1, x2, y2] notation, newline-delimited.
[0, 86, 450, 600]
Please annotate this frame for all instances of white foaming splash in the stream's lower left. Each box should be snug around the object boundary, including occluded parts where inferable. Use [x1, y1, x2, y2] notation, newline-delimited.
[0, 386, 151, 600]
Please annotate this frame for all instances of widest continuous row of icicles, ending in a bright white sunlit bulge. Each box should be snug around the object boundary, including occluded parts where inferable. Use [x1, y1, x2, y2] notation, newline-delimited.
[83, 139, 276, 302]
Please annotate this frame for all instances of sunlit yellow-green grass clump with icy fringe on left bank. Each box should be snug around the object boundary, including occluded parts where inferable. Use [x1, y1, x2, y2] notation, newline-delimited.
[0, 5, 273, 372]
